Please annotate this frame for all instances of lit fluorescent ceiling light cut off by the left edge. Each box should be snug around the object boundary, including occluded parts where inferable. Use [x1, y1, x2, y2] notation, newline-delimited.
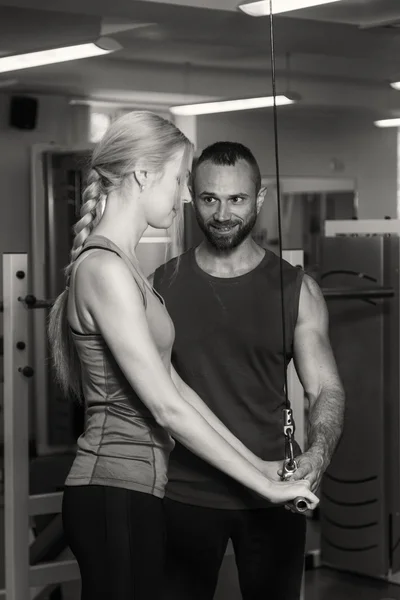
[0, 37, 121, 73]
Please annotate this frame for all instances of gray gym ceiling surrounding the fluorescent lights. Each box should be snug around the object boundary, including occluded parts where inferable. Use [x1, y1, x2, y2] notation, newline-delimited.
[0, 0, 400, 114]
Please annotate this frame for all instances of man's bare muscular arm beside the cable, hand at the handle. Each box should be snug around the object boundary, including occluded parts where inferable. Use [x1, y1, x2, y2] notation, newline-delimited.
[294, 275, 345, 491]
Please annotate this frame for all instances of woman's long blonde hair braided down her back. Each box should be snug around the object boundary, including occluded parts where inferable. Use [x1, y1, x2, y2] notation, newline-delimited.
[48, 111, 193, 398]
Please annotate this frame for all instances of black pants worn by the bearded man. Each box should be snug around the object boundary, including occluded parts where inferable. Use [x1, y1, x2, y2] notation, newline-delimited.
[164, 499, 306, 600]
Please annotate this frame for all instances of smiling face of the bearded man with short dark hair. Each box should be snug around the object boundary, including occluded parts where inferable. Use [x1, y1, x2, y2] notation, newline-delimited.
[193, 160, 265, 250]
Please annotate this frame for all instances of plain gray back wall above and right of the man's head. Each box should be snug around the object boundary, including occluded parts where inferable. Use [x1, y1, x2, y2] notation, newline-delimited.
[197, 106, 397, 219]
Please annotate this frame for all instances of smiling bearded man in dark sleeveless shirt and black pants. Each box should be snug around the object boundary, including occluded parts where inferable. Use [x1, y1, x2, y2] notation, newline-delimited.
[154, 142, 344, 600]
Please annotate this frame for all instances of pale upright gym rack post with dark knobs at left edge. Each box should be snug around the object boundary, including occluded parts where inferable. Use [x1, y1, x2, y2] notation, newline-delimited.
[0, 254, 79, 600]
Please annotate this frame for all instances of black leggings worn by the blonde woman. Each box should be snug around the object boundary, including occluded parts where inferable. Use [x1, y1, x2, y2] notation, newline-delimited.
[62, 485, 165, 600]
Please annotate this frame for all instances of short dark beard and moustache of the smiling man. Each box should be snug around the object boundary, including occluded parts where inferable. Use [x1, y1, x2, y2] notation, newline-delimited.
[195, 208, 257, 250]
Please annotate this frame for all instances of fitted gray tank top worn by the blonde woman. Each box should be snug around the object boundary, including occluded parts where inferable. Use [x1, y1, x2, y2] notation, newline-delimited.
[65, 236, 175, 498]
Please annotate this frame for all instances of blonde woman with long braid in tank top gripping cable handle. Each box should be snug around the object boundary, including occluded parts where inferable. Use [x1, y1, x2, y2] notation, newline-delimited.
[49, 112, 318, 600]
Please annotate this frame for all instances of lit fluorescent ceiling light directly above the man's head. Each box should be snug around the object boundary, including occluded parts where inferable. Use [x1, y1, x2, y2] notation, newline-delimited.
[170, 95, 298, 116]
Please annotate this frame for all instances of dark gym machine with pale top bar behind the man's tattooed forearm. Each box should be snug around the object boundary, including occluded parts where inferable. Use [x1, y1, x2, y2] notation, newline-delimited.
[319, 220, 400, 584]
